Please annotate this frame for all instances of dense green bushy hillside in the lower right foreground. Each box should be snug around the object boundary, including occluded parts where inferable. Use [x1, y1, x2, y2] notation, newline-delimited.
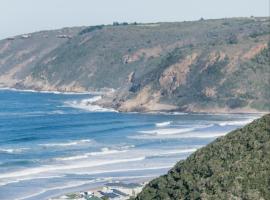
[136, 114, 270, 200]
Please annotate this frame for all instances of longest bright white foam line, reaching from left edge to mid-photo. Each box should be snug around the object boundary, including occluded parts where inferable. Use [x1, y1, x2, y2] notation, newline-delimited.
[0, 156, 145, 179]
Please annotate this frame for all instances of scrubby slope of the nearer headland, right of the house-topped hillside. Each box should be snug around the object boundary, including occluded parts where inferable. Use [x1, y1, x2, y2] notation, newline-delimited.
[32, 18, 270, 111]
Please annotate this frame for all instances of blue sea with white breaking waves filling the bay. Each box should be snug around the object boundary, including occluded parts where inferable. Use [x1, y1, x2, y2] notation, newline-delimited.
[0, 90, 260, 200]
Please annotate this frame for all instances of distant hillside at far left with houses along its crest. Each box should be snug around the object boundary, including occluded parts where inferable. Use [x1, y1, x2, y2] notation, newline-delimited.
[0, 27, 83, 87]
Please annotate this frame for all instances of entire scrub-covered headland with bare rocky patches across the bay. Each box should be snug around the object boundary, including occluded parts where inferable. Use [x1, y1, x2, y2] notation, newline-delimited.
[0, 18, 270, 112]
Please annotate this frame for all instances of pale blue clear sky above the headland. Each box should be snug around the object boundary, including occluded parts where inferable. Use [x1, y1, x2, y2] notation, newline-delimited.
[0, 0, 270, 39]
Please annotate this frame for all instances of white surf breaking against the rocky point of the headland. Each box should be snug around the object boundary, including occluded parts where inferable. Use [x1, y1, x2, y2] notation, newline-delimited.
[65, 96, 117, 112]
